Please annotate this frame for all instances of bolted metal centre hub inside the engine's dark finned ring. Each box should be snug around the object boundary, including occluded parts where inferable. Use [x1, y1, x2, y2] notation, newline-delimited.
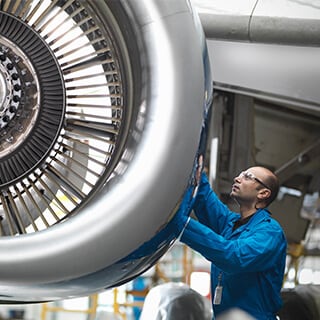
[0, 39, 39, 157]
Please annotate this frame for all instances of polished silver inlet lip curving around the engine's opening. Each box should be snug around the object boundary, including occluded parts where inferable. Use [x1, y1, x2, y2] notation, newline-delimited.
[0, 0, 212, 302]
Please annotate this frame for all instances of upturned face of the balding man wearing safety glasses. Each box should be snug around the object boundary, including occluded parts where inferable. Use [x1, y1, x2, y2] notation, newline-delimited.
[230, 167, 266, 203]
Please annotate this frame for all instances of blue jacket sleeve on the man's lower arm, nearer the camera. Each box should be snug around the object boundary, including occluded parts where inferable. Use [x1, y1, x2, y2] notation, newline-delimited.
[180, 219, 286, 273]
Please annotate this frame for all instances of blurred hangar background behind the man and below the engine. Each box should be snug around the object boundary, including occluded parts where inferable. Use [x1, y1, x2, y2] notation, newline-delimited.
[0, 57, 320, 320]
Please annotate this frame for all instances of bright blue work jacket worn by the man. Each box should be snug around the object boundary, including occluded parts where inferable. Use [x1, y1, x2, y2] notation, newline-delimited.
[180, 173, 287, 320]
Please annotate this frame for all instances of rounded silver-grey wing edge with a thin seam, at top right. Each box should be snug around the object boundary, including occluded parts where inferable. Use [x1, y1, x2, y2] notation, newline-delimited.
[192, 0, 320, 46]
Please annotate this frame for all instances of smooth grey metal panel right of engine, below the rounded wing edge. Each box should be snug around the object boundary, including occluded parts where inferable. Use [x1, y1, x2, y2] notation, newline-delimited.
[207, 40, 320, 115]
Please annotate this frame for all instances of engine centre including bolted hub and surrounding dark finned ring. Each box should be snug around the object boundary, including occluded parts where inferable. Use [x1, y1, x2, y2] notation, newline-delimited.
[0, 12, 65, 189]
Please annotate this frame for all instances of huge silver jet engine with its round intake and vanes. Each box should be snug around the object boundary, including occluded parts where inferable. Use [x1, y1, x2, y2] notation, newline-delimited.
[0, 0, 212, 303]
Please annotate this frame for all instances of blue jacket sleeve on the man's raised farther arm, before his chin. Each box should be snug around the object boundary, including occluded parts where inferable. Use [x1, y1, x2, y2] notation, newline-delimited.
[193, 172, 235, 233]
